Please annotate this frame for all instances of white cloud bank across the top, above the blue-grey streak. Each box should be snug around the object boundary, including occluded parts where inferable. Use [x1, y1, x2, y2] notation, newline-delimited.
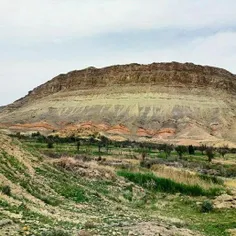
[0, 0, 236, 42]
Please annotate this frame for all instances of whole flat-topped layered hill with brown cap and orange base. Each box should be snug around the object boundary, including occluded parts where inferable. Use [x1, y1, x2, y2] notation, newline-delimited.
[0, 62, 236, 146]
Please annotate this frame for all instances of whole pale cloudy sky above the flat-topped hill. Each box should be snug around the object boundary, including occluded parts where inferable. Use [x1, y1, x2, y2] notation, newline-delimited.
[0, 0, 236, 106]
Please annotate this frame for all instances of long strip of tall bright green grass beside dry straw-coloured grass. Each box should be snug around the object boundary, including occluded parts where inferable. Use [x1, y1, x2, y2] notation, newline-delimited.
[117, 170, 220, 196]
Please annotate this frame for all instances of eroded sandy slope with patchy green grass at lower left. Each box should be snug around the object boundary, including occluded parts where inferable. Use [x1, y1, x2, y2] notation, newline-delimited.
[0, 134, 204, 236]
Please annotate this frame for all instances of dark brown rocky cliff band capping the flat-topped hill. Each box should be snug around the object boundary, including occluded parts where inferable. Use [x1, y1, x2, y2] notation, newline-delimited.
[23, 62, 236, 97]
